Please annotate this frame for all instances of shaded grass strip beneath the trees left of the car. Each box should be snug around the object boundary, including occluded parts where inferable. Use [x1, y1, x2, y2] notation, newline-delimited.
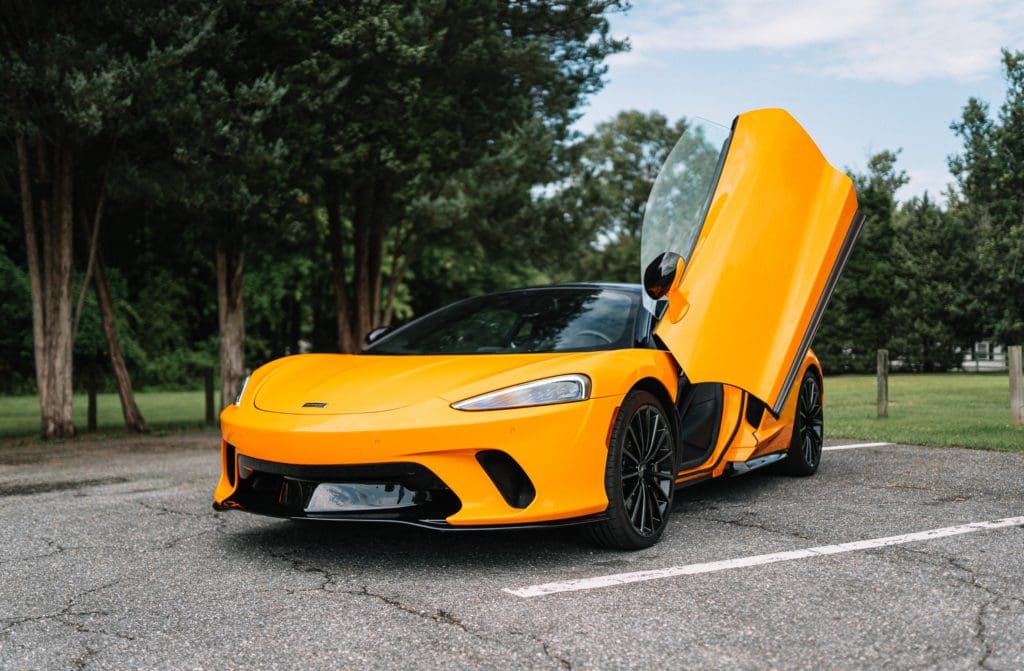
[0, 391, 206, 436]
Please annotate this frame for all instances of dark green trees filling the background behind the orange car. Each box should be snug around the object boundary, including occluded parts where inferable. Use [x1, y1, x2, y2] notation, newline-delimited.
[0, 0, 1024, 436]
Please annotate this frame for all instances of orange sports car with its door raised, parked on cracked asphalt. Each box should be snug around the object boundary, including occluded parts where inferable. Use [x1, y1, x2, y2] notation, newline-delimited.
[214, 110, 863, 549]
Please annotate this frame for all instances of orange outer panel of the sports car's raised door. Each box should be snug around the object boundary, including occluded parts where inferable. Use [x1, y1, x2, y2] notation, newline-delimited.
[655, 110, 857, 413]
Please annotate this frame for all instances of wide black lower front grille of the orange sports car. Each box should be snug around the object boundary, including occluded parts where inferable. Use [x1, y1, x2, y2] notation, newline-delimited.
[225, 454, 462, 520]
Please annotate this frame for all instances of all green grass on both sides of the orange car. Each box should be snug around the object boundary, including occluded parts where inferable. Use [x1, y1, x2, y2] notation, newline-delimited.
[0, 374, 1024, 452]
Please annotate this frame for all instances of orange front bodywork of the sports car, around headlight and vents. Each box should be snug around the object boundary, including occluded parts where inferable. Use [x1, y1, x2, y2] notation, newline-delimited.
[214, 349, 678, 526]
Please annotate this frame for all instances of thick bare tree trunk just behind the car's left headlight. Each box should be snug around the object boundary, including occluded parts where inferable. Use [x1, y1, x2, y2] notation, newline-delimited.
[217, 240, 246, 408]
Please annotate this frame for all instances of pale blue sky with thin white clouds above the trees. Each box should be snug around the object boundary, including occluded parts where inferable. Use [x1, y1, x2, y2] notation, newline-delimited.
[577, 0, 1024, 199]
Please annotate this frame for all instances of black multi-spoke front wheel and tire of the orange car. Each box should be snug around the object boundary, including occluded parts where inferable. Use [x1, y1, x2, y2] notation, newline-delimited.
[584, 389, 676, 550]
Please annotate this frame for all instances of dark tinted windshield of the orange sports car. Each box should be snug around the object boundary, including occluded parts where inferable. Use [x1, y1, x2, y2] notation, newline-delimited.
[367, 287, 640, 354]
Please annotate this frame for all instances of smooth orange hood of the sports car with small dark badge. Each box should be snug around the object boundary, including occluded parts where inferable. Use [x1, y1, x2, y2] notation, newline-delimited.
[254, 352, 592, 415]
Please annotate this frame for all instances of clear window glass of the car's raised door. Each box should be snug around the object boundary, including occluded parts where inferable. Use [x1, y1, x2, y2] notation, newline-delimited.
[640, 119, 730, 311]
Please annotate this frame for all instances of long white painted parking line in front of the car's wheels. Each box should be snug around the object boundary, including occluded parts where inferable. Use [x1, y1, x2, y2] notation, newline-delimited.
[503, 516, 1024, 598]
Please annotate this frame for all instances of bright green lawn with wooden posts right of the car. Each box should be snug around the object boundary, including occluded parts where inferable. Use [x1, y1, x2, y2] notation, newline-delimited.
[825, 373, 1024, 452]
